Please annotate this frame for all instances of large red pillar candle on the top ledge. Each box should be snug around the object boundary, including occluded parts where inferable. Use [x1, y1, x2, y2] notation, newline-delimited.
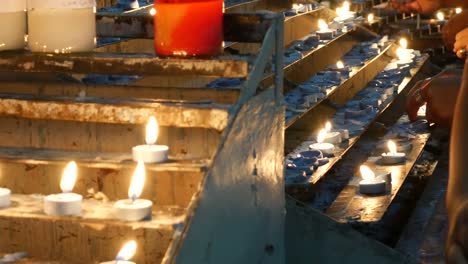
[154, 0, 224, 56]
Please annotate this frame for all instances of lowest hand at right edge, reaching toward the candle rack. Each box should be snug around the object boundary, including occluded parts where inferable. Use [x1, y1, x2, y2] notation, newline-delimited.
[406, 73, 461, 128]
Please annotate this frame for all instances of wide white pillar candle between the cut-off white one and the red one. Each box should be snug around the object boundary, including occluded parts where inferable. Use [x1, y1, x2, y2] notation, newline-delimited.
[28, 0, 96, 53]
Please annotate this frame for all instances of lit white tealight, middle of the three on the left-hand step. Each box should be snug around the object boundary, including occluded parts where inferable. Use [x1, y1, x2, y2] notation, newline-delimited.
[44, 161, 83, 216]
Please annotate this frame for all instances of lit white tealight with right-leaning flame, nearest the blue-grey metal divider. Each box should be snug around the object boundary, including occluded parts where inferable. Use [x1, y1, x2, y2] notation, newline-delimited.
[113, 162, 153, 221]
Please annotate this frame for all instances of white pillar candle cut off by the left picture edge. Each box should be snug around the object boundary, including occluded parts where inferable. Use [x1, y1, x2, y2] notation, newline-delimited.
[0, 0, 26, 51]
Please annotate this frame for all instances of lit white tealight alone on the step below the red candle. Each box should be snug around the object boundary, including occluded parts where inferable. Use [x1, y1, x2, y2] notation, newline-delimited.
[132, 116, 169, 163]
